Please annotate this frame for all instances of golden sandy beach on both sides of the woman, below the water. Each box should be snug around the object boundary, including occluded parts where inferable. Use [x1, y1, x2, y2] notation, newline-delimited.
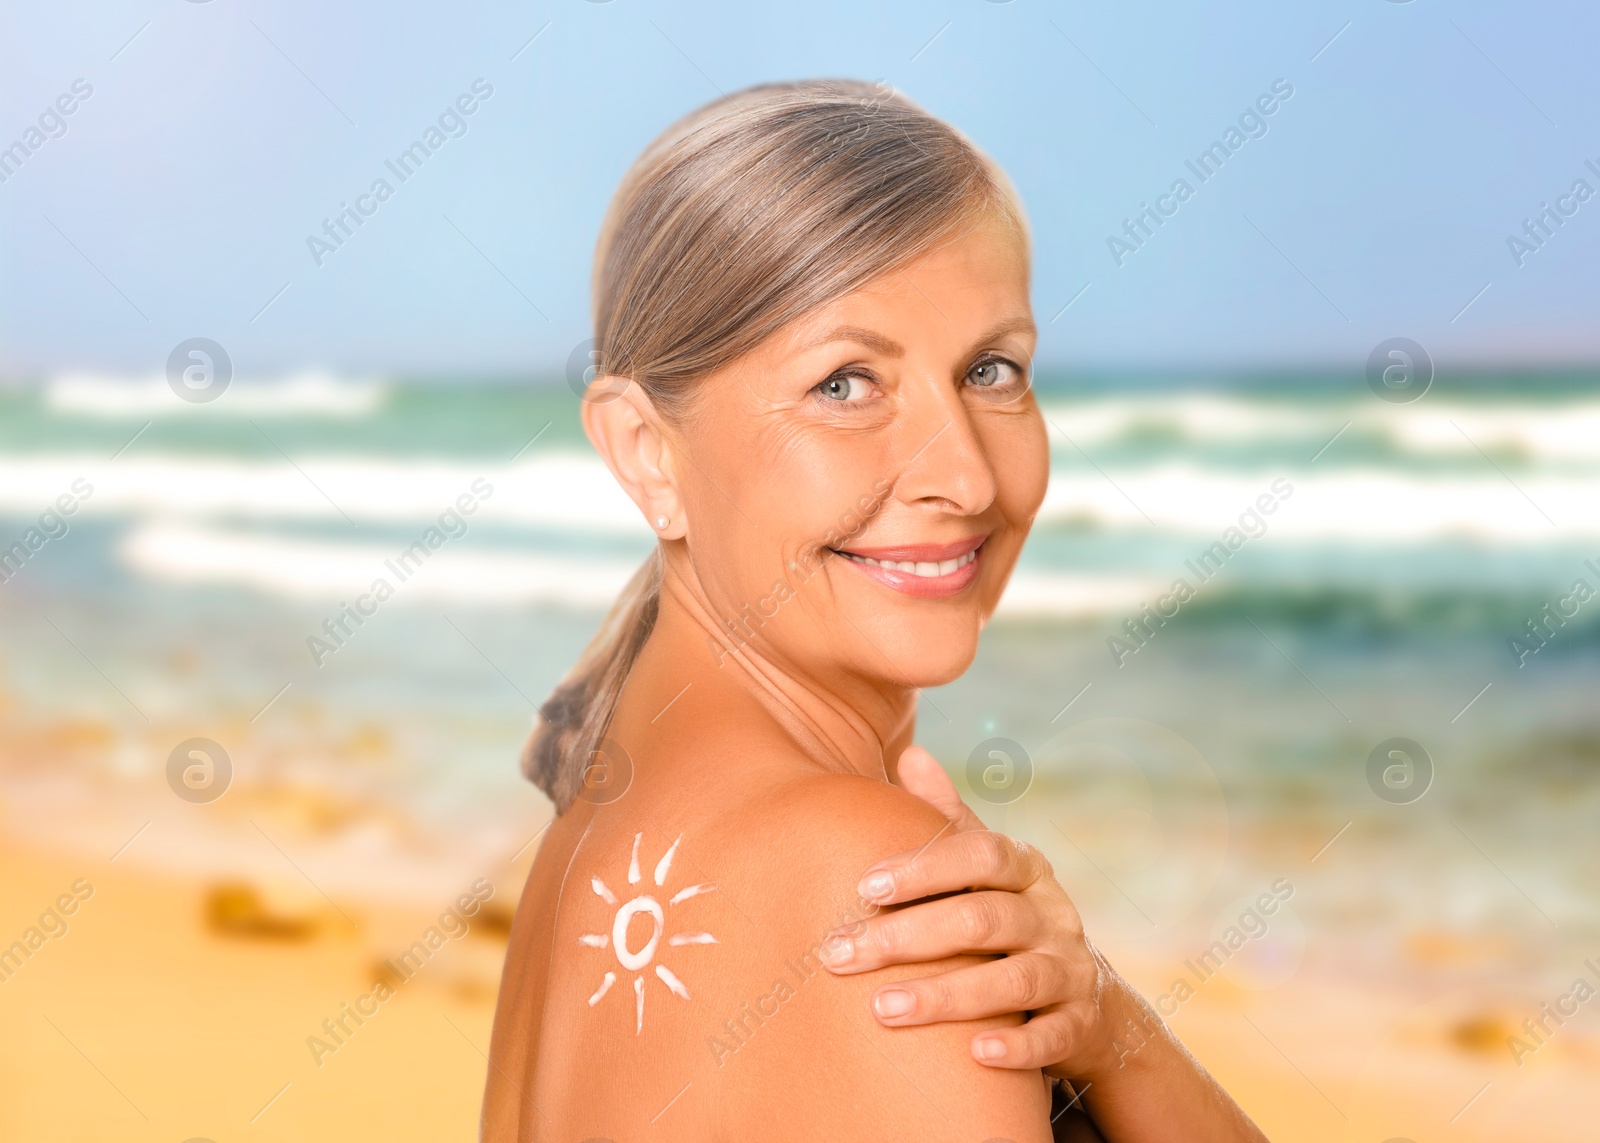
[0, 810, 1600, 1143]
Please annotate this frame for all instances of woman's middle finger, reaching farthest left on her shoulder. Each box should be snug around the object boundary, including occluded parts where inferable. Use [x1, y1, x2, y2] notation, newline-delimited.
[819, 892, 1045, 973]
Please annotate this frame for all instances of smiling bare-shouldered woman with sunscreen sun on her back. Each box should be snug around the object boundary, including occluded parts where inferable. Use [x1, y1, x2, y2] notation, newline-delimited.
[483, 82, 1262, 1143]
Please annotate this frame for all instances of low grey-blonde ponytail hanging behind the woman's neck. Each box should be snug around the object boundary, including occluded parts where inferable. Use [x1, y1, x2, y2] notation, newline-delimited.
[522, 547, 661, 813]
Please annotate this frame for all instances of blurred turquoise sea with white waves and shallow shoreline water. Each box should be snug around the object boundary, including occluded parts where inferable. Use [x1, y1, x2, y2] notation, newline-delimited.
[0, 370, 1600, 1010]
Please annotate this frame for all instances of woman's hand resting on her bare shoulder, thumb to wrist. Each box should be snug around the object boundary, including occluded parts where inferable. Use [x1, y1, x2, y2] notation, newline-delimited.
[822, 746, 1123, 1082]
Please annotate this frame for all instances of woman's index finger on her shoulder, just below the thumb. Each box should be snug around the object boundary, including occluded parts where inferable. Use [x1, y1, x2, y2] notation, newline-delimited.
[856, 829, 1050, 904]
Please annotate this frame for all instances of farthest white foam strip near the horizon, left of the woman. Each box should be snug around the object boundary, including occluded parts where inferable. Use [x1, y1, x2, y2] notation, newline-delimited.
[45, 370, 389, 418]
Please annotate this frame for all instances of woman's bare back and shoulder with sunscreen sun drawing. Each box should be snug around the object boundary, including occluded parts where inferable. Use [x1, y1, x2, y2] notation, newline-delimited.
[483, 717, 1048, 1143]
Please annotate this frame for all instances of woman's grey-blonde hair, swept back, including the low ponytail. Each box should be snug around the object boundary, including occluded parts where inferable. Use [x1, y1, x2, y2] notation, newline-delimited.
[522, 80, 1026, 813]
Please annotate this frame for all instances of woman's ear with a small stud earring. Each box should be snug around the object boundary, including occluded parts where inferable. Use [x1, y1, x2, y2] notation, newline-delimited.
[582, 378, 688, 539]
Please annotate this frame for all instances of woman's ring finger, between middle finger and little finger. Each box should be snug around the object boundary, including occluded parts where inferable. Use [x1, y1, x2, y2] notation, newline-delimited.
[851, 953, 1074, 1030]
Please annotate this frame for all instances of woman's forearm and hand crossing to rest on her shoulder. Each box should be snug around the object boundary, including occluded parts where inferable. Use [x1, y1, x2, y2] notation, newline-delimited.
[827, 748, 1266, 1143]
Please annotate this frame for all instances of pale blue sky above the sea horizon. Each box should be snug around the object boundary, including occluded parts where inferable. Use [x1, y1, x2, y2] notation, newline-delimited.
[0, 0, 1600, 376]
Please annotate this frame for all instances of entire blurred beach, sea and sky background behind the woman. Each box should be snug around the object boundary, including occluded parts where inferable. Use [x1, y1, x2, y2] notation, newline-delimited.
[0, 0, 1600, 1143]
